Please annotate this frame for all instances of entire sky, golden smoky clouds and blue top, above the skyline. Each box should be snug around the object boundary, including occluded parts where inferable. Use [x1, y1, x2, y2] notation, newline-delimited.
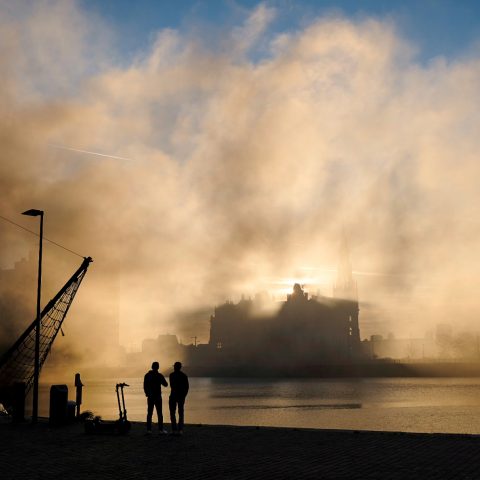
[0, 0, 480, 356]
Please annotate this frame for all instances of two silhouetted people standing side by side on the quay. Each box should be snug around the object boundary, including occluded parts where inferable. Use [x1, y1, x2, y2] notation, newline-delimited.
[143, 362, 189, 434]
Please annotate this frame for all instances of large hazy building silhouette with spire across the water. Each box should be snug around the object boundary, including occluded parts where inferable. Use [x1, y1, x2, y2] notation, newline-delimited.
[186, 243, 362, 369]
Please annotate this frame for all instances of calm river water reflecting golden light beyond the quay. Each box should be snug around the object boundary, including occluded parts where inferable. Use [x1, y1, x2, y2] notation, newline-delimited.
[40, 378, 480, 434]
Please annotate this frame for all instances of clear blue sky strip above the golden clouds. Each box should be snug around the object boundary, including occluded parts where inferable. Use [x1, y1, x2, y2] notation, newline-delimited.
[80, 0, 480, 61]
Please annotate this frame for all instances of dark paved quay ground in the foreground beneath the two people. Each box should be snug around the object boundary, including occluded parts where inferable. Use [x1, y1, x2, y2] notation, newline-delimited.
[0, 421, 480, 480]
